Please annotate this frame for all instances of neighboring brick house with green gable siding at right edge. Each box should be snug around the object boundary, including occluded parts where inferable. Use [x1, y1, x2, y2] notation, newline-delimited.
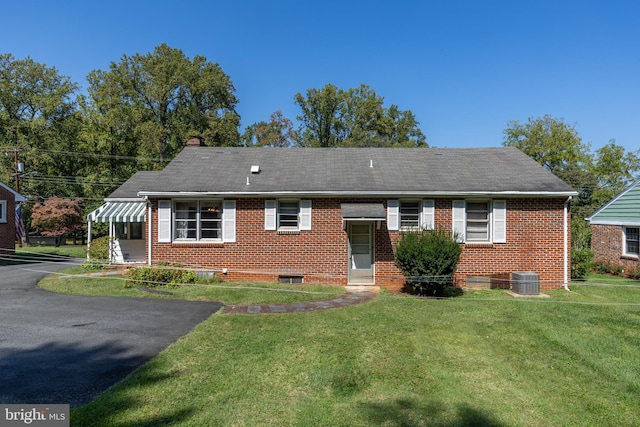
[587, 181, 640, 268]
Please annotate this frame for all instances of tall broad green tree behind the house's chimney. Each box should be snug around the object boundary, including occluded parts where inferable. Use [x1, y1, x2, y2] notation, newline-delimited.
[88, 44, 240, 168]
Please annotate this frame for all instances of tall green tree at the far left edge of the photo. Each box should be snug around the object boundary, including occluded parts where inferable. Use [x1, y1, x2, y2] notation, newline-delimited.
[0, 54, 82, 195]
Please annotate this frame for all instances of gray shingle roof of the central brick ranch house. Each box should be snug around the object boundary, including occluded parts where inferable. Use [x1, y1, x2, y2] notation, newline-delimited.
[110, 147, 576, 197]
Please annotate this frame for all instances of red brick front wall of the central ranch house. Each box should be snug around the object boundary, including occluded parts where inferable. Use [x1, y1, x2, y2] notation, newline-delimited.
[152, 199, 564, 289]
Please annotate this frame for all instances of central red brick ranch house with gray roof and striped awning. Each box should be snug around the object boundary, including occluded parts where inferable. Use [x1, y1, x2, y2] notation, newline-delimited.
[88, 140, 577, 289]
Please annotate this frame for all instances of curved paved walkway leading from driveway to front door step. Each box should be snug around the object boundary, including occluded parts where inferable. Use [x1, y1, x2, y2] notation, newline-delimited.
[222, 289, 379, 314]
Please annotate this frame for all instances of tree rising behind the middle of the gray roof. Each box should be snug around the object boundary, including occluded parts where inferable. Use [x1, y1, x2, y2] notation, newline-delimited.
[294, 84, 427, 147]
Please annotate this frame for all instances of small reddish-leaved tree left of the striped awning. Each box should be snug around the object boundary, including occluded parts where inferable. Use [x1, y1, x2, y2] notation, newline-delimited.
[31, 197, 82, 242]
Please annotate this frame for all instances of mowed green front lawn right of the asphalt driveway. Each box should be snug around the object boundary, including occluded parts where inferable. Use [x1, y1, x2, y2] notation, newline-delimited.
[58, 281, 640, 426]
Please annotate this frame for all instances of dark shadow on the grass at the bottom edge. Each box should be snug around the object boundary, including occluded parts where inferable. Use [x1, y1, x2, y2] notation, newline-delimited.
[361, 399, 504, 427]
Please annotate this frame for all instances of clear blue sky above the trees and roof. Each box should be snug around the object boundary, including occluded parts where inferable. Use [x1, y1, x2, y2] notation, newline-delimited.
[0, 0, 640, 151]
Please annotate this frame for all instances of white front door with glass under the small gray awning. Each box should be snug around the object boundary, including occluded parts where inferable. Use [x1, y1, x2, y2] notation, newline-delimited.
[349, 222, 374, 283]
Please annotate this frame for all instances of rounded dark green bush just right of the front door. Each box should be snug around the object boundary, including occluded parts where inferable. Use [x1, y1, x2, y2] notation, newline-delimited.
[395, 229, 462, 296]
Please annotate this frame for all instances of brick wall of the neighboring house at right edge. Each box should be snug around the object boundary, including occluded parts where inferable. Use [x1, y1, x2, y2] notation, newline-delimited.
[591, 224, 640, 269]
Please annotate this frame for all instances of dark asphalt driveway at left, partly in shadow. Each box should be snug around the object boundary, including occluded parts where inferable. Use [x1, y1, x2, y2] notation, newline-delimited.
[0, 263, 222, 407]
